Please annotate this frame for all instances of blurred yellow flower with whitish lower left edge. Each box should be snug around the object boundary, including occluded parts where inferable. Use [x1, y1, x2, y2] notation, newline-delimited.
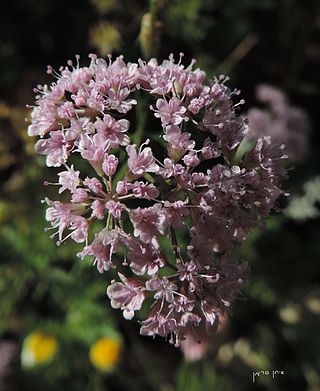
[21, 332, 58, 368]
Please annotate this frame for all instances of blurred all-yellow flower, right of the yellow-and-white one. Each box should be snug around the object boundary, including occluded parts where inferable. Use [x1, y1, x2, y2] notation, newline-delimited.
[89, 337, 121, 371]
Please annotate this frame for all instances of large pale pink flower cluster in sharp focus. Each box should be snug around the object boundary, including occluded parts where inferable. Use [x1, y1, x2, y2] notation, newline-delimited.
[28, 55, 286, 344]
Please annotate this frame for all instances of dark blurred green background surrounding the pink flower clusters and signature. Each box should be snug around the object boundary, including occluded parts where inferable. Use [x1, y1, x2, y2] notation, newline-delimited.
[0, 0, 320, 391]
